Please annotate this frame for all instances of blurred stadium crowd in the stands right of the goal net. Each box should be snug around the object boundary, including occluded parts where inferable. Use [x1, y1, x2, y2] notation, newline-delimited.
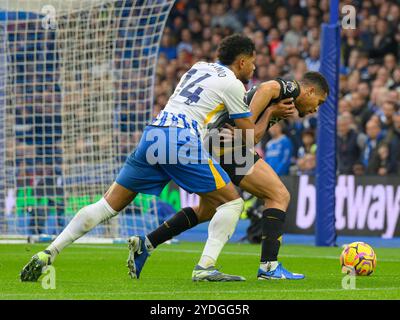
[154, 0, 400, 176]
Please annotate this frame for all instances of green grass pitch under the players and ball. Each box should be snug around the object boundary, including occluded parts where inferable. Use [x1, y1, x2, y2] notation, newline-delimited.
[0, 242, 400, 300]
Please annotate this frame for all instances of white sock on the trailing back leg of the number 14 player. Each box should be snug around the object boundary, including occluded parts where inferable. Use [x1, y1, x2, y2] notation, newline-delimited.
[46, 198, 118, 261]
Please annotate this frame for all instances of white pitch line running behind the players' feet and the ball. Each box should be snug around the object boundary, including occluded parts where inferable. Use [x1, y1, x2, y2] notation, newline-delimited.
[72, 245, 400, 262]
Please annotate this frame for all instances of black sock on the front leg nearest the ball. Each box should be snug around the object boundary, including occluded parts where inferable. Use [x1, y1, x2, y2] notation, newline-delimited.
[260, 208, 286, 263]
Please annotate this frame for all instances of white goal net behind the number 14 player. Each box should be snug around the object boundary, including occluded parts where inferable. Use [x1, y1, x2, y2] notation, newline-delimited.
[0, 0, 174, 238]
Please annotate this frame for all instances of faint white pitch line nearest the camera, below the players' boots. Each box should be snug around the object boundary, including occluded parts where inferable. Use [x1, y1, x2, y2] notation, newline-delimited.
[0, 287, 400, 297]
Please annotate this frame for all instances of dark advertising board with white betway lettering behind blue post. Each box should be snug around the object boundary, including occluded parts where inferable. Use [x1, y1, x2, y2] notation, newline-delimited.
[282, 176, 400, 238]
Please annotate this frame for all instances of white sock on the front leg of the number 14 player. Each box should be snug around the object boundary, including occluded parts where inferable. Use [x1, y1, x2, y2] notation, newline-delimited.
[198, 198, 244, 268]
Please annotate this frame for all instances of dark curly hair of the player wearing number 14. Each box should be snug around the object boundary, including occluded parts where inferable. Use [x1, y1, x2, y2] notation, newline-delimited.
[218, 33, 256, 66]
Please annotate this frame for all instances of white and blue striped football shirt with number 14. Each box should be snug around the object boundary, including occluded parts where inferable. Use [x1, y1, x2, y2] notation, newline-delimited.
[152, 62, 251, 137]
